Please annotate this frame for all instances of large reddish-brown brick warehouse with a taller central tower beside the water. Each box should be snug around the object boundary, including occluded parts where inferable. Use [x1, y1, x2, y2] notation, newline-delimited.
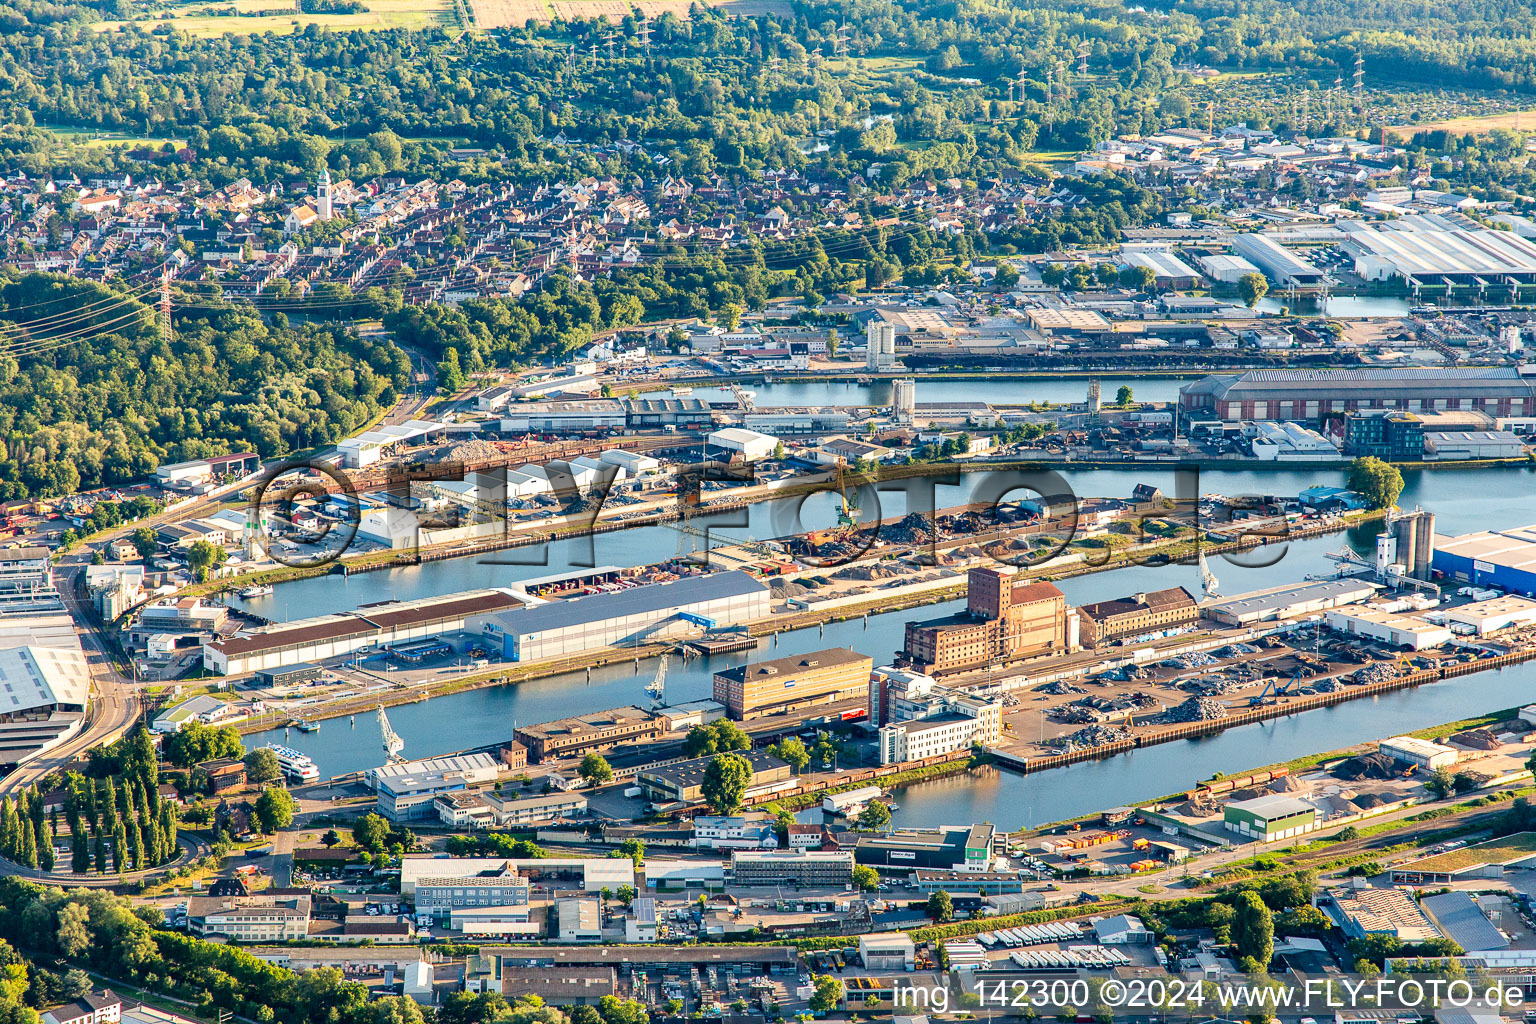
[905, 568, 1077, 674]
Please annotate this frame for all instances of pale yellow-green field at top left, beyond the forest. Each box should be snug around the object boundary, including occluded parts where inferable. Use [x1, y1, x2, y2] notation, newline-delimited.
[95, 0, 458, 38]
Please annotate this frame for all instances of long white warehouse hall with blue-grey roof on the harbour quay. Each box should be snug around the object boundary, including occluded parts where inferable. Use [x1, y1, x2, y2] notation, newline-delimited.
[479, 571, 773, 662]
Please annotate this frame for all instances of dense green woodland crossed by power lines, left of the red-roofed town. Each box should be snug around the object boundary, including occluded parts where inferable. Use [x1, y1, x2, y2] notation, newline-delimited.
[0, 273, 410, 499]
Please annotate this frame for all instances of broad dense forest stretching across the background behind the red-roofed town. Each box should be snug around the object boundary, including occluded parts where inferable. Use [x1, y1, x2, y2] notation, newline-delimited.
[0, 0, 1536, 183]
